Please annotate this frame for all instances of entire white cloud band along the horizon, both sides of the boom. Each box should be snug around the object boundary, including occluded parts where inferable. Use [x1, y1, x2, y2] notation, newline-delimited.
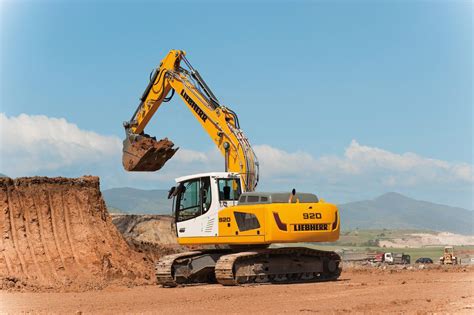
[0, 113, 474, 208]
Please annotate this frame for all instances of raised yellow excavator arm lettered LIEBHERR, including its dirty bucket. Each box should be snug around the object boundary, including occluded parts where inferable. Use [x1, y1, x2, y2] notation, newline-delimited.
[122, 50, 258, 191]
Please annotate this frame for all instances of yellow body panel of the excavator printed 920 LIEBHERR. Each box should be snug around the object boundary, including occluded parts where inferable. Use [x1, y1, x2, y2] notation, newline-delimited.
[179, 202, 340, 245]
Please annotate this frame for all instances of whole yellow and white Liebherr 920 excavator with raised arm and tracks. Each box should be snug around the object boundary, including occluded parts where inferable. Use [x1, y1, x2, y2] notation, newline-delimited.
[122, 50, 342, 287]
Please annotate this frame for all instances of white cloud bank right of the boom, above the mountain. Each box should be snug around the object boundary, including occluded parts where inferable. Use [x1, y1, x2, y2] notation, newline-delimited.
[255, 140, 473, 187]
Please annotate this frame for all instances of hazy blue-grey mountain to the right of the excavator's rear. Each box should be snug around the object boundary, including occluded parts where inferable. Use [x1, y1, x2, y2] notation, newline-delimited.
[339, 192, 474, 234]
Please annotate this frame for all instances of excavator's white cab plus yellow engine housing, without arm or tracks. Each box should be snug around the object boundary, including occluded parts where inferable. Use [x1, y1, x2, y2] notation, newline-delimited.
[171, 172, 340, 245]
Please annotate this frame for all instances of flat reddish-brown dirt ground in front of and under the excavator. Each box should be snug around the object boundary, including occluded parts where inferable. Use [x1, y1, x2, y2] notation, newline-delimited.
[0, 269, 474, 314]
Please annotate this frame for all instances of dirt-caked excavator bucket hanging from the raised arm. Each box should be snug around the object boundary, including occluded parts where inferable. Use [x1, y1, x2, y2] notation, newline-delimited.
[122, 136, 178, 172]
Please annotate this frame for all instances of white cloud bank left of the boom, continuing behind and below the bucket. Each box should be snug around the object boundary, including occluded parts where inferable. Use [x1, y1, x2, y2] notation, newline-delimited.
[0, 113, 224, 187]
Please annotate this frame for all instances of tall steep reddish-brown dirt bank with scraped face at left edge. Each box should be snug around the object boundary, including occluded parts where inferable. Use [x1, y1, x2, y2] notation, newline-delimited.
[0, 176, 153, 290]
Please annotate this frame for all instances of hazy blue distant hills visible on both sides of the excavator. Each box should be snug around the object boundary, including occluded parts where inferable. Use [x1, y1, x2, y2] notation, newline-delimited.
[103, 188, 474, 235]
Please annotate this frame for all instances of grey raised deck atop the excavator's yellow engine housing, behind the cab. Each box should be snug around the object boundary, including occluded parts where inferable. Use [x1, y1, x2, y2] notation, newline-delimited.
[239, 192, 319, 205]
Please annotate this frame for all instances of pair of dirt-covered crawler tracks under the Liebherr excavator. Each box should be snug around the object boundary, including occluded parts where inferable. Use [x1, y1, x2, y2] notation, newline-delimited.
[156, 247, 341, 287]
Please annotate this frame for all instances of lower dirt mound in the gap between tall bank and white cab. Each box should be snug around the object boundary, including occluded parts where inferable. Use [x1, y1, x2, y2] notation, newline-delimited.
[112, 214, 185, 261]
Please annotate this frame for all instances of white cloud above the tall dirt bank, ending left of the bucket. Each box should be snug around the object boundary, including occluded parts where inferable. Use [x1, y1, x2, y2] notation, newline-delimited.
[0, 113, 122, 176]
